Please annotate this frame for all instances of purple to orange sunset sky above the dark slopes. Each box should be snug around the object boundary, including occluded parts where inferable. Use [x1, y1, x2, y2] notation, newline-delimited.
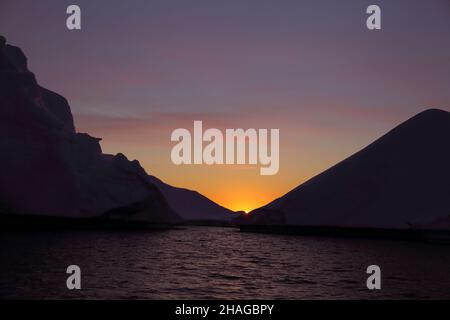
[0, 0, 450, 211]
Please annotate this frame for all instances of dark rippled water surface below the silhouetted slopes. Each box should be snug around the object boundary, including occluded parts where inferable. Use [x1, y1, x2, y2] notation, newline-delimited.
[0, 227, 450, 299]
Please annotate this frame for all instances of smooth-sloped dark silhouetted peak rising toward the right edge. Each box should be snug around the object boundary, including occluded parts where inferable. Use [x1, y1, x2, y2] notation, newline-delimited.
[243, 109, 450, 228]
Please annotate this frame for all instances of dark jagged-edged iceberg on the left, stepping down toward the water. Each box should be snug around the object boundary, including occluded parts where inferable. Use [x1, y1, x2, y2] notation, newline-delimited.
[0, 37, 181, 224]
